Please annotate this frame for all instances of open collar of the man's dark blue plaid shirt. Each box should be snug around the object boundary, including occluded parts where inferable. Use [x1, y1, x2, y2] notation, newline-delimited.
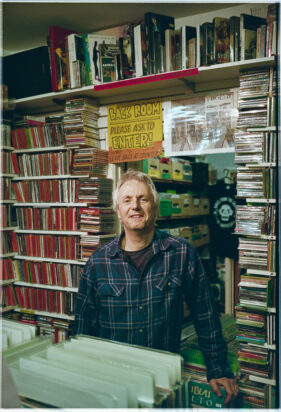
[108, 229, 175, 257]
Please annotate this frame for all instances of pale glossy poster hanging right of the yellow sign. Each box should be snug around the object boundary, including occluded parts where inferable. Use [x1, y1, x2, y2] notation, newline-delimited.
[164, 89, 238, 156]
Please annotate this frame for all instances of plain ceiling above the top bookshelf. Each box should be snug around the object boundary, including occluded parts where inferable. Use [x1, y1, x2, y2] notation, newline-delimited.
[2, 1, 241, 54]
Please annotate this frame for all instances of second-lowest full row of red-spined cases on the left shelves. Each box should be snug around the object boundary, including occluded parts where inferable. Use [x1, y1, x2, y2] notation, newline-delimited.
[11, 260, 81, 288]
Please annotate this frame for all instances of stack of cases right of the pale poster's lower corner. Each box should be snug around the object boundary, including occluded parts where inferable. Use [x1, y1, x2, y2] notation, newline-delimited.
[234, 130, 277, 164]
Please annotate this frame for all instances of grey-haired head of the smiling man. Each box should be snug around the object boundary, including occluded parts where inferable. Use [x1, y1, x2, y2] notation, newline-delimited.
[113, 169, 159, 231]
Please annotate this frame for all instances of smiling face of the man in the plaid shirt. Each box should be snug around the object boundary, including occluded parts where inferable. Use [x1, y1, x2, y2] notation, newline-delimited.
[117, 180, 156, 233]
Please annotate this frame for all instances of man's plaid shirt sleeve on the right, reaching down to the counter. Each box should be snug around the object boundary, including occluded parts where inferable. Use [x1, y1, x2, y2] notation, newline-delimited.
[186, 245, 234, 381]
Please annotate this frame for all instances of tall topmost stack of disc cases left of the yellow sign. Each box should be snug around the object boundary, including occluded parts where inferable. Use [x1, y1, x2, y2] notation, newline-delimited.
[63, 97, 100, 148]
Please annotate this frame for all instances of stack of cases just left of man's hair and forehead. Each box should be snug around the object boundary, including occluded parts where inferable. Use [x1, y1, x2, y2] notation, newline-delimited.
[77, 176, 113, 206]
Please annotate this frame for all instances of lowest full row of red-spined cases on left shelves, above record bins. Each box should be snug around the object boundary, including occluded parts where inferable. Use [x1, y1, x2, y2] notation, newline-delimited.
[14, 285, 76, 315]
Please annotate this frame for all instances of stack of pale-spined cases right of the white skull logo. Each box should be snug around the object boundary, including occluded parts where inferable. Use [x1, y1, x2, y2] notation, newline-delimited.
[234, 204, 276, 236]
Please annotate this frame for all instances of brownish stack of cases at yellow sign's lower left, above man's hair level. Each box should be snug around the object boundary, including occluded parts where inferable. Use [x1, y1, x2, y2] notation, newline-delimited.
[72, 147, 108, 176]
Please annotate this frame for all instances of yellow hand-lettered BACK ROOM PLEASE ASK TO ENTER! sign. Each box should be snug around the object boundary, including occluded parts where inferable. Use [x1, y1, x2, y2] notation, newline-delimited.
[107, 100, 163, 163]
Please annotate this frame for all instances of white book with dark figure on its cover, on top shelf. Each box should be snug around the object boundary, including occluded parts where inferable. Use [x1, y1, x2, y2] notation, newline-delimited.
[82, 33, 116, 84]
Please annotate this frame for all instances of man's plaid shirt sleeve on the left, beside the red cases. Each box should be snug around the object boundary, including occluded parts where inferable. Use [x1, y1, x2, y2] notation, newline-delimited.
[73, 258, 99, 336]
